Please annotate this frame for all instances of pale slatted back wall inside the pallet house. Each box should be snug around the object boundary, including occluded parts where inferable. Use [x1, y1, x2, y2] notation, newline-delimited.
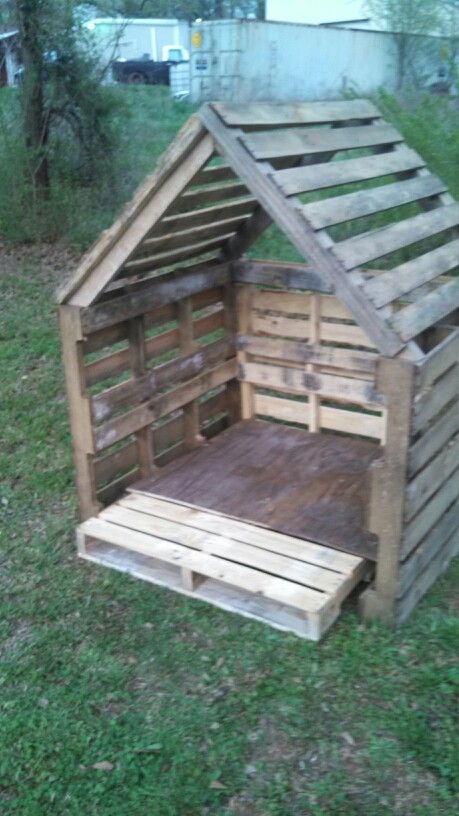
[237, 285, 385, 442]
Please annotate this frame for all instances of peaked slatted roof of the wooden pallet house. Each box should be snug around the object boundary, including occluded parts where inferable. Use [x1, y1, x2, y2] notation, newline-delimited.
[57, 99, 459, 356]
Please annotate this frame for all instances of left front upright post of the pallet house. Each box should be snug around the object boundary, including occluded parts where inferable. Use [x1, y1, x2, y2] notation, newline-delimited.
[59, 306, 100, 521]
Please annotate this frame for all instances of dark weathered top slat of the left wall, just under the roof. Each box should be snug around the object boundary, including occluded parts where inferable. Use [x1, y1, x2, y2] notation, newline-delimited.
[82, 264, 229, 334]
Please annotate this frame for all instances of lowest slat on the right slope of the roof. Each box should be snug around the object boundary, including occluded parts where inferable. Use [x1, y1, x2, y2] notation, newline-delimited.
[390, 278, 459, 340]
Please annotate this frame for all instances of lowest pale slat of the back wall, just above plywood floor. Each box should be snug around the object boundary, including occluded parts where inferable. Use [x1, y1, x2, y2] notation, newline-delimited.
[255, 394, 384, 439]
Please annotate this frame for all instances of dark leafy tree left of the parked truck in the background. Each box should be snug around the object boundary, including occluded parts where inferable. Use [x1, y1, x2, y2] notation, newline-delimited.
[2, 0, 119, 190]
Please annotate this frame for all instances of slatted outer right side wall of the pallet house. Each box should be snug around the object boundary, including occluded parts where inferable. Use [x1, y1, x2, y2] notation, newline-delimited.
[397, 329, 459, 621]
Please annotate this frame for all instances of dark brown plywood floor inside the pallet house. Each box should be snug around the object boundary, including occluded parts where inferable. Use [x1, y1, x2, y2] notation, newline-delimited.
[132, 420, 381, 560]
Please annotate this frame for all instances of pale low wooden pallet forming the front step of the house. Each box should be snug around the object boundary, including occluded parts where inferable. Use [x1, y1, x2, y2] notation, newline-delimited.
[77, 492, 369, 640]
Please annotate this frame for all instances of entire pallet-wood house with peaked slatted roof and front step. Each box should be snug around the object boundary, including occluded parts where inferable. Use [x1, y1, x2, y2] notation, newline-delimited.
[58, 100, 459, 639]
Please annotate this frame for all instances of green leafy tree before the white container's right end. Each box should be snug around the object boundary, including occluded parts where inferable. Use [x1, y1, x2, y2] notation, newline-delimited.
[366, 0, 442, 89]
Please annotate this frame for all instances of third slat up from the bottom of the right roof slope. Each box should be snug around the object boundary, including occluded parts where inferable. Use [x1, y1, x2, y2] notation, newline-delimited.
[333, 202, 459, 269]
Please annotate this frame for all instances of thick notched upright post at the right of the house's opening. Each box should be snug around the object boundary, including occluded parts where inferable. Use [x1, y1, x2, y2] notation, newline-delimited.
[360, 358, 415, 626]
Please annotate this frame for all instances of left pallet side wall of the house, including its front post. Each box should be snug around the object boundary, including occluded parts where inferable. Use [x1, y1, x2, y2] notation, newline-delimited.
[60, 265, 240, 519]
